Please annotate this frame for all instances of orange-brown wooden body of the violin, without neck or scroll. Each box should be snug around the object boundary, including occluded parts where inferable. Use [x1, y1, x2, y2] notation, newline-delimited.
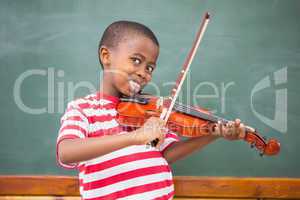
[118, 97, 209, 137]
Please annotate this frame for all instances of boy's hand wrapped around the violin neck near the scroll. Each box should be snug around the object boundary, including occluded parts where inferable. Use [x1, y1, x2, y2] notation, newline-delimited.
[212, 119, 245, 140]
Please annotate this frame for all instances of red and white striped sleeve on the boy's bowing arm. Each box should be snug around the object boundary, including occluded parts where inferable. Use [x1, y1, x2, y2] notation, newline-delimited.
[56, 102, 88, 169]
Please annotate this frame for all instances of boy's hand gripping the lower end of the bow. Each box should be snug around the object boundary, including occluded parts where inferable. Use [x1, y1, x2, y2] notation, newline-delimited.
[134, 117, 165, 148]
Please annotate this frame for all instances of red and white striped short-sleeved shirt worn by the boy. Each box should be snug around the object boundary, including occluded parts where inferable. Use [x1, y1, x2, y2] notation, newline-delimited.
[56, 93, 179, 199]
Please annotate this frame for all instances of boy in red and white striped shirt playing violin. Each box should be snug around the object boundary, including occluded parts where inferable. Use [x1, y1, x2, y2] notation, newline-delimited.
[57, 21, 244, 199]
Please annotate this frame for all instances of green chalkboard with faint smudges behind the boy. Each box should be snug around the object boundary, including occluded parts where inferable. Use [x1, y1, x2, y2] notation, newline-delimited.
[0, 0, 300, 177]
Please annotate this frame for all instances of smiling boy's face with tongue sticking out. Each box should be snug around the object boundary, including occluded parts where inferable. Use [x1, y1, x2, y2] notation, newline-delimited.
[104, 36, 159, 96]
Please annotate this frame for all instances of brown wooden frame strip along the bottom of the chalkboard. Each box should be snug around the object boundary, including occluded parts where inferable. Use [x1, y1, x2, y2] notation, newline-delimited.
[0, 176, 300, 199]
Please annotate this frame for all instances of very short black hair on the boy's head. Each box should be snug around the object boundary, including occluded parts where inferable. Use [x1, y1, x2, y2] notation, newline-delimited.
[98, 20, 159, 68]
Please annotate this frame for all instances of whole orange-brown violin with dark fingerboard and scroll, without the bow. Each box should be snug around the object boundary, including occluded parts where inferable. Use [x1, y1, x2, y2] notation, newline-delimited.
[117, 95, 280, 156]
